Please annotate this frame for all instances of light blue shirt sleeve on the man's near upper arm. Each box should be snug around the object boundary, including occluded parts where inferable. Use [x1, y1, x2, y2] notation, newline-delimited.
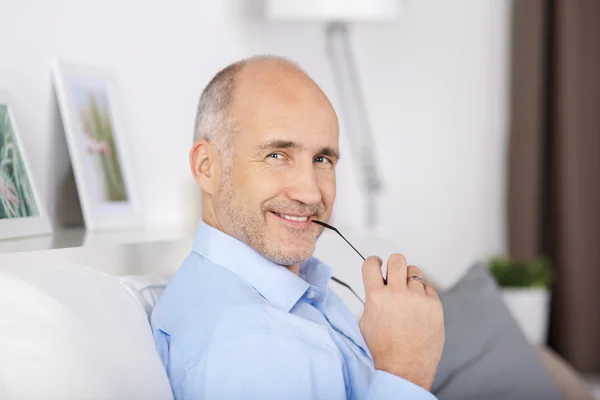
[173, 333, 347, 400]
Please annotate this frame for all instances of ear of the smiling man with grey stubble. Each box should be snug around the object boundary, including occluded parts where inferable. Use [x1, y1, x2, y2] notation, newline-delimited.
[190, 139, 221, 195]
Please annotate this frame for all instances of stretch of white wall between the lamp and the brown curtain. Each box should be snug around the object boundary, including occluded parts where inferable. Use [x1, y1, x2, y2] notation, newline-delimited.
[346, 0, 511, 284]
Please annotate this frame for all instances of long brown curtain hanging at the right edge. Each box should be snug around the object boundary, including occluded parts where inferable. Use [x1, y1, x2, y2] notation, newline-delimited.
[508, 0, 600, 373]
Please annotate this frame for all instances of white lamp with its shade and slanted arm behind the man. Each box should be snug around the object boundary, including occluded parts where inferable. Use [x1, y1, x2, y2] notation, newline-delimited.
[266, 0, 399, 228]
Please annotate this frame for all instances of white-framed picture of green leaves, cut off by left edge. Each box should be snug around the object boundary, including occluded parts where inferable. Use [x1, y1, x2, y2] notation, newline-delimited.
[0, 92, 52, 239]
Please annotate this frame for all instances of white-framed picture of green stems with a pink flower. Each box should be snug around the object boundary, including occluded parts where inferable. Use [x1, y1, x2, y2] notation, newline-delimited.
[52, 60, 141, 231]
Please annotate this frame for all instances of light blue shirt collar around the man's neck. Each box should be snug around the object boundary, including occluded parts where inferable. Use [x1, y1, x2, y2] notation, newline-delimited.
[194, 221, 331, 312]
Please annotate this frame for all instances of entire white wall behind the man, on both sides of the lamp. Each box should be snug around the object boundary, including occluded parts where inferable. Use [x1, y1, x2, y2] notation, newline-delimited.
[0, 0, 510, 284]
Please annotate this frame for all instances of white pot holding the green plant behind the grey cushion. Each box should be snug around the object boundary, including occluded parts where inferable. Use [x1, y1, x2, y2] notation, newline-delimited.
[502, 288, 550, 345]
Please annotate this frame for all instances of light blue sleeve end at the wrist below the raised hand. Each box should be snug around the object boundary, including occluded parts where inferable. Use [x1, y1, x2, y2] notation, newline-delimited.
[367, 370, 437, 400]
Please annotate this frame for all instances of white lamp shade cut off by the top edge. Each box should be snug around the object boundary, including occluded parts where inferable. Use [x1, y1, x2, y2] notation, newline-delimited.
[266, 0, 400, 22]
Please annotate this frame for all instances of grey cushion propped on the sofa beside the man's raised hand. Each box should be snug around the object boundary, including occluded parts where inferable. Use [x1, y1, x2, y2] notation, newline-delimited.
[432, 264, 560, 400]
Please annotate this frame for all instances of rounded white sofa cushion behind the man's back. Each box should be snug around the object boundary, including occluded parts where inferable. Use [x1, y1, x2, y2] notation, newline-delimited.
[0, 265, 172, 399]
